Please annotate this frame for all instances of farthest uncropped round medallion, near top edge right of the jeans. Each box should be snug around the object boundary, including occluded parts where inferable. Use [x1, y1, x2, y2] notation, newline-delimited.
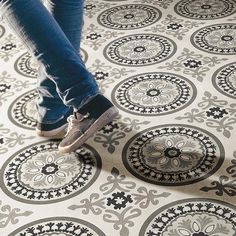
[98, 4, 161, 30]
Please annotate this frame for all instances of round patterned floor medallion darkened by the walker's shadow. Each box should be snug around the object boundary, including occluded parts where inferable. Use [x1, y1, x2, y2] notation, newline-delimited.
[122, 125, 224, 186]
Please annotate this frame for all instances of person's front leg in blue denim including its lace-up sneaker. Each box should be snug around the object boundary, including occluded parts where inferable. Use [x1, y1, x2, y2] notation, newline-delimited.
[0, 0, 118, 152]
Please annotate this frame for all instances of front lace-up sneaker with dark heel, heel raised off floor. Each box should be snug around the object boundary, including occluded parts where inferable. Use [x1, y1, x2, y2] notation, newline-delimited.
[58, 94, 118, 153]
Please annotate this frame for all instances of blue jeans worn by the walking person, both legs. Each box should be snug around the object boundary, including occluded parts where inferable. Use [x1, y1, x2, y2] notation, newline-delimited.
[0, 0, 99, 123]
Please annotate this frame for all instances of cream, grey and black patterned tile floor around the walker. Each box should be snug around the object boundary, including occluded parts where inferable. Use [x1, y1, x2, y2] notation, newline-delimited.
[0, 0, 236, 236]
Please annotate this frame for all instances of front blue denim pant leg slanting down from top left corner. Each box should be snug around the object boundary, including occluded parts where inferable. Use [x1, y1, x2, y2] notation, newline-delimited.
[0, 0, 99, 116]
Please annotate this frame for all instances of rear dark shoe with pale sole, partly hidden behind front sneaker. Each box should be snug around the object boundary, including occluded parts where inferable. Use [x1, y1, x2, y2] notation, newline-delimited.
[36, 109, 73, 138]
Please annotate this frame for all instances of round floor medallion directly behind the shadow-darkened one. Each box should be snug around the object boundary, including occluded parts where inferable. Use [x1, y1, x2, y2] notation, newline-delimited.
[112, 72, 197, 116]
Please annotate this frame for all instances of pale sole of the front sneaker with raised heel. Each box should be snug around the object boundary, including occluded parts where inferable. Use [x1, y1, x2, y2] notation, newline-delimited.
[58, 107, 119, 153]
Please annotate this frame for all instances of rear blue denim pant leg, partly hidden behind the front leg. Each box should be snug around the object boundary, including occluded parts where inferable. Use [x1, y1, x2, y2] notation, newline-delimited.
[37, 0, 83, 123]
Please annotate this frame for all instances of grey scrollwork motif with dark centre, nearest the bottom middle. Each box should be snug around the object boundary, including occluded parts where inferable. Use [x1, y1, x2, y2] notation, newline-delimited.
[68, 168, 170, 236]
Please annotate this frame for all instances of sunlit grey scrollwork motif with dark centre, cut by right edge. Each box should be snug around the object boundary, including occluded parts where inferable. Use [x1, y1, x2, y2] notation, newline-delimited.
[176, 91, 236, 138]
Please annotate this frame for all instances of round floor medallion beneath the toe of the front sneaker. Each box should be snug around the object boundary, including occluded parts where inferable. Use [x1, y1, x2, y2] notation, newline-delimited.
[0, 140, 101, 204]
